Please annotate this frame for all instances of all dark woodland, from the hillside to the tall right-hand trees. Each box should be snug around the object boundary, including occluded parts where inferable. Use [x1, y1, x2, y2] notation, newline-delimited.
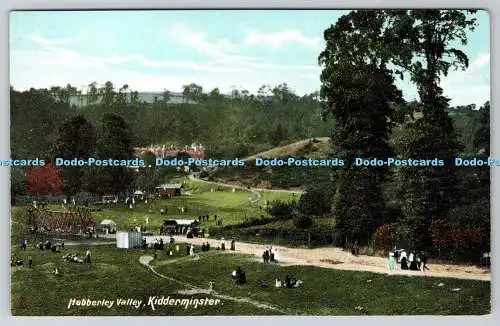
[10, 10, 490, 257]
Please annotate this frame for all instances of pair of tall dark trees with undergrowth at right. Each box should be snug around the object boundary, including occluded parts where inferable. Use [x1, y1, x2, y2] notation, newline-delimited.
[319, 9, 490, 259]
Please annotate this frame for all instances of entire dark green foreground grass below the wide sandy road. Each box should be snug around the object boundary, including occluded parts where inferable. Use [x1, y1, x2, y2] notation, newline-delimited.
[12, 246, 490, 316]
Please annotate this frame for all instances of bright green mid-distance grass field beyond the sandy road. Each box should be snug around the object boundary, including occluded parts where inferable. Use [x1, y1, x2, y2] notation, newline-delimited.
[11, 180, 294, 243]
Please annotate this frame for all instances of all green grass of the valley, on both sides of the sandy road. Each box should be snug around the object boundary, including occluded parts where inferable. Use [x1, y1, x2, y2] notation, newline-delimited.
[11, 180, 491, 316]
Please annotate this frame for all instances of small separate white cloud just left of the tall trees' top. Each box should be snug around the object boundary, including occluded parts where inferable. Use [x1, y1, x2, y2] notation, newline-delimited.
[243, 29, 321, 49]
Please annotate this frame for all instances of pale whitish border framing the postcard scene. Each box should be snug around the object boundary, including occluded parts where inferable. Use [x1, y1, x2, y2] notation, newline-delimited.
[0, 0, 500, 326]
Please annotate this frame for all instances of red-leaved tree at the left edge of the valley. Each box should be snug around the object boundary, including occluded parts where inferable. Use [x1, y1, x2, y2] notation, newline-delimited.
[26, 163, 64, 196]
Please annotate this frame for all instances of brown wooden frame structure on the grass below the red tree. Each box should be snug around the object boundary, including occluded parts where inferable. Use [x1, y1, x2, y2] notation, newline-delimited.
[24, 206, 95, 236]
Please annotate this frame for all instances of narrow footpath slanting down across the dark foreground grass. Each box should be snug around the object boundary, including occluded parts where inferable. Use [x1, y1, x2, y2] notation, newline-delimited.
[139, 256, 290, 315]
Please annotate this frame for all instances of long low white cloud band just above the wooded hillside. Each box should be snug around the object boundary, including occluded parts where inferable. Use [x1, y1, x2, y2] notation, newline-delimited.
[10, 33, 317, 94]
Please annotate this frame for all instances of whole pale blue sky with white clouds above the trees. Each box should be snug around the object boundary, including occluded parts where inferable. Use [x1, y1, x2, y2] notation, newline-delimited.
[10, 10, 490, 107]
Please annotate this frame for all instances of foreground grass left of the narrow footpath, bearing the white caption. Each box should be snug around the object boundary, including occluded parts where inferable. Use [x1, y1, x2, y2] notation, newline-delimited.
[11, 246, 276, 316]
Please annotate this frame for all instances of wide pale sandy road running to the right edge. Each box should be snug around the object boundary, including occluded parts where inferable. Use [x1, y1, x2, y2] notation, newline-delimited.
[146, 236, 491, 281]
